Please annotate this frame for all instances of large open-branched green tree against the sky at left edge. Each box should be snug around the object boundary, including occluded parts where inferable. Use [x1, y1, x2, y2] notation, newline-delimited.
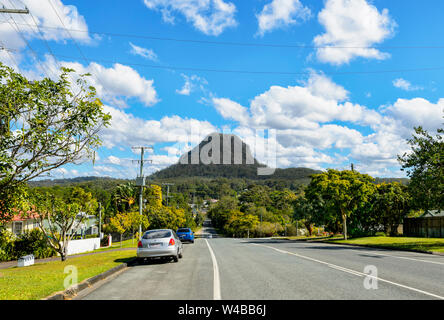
[0, 63, 111, 222]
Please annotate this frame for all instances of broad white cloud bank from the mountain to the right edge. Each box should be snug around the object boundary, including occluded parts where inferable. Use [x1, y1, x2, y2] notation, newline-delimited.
[212, 73, 444, 177]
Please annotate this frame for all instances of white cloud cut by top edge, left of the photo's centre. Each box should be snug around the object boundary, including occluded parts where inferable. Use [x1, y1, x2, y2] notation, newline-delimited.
[144, 0, 237, 36]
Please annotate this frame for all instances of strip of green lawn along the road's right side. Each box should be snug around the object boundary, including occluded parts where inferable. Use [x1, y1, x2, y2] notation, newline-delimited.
[327, 237, 444, 252]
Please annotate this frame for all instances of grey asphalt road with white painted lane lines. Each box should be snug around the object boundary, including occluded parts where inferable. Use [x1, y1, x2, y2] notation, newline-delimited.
[78, 220, 444, 300]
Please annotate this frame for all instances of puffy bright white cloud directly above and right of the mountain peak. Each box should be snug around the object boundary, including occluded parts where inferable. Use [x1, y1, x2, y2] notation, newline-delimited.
[213, 73, 380, 130]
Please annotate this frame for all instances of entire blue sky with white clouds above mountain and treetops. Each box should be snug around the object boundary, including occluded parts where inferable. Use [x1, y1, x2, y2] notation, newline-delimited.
[0, 0, 444, 178]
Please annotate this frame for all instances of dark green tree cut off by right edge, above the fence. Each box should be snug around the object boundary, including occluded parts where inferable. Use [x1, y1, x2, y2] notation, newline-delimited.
[398, 127, 444, 212]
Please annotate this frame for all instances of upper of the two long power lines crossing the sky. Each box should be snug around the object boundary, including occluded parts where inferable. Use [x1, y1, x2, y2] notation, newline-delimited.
[2, 19, 444, 49]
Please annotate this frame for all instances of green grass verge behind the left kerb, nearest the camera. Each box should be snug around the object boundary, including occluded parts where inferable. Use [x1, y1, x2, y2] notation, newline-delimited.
[0, 250, 136, 300]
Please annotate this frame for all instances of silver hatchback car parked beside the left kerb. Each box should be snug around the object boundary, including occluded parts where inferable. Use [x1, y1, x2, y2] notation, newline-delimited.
[137, 229, 183, 262]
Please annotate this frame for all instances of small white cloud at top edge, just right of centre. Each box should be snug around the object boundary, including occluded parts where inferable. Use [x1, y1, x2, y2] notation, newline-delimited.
[256, 0, 311, 35]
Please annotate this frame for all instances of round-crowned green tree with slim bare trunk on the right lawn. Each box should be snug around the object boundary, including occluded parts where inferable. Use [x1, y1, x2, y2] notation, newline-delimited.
[306, 169, 375, 239]
